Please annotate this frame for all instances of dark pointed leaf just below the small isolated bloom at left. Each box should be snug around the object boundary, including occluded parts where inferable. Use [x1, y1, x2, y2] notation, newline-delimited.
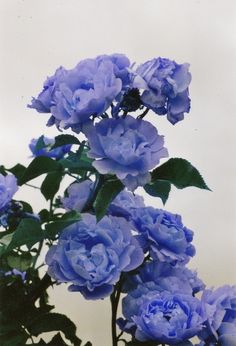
[19, 156, 62, 185]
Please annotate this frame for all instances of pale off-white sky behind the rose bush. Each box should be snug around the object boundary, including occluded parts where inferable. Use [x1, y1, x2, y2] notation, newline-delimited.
[0, 0, 236, 346]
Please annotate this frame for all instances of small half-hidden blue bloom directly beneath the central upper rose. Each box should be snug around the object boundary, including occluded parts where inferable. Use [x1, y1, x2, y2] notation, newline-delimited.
[109, 190, 145, 220]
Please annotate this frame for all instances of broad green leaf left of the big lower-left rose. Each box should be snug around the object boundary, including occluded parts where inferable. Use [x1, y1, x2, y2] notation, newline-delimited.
[7, 219, 44, 251]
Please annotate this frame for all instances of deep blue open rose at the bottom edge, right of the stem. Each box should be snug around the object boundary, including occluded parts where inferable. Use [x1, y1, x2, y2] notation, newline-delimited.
[122, 284, 206, 345]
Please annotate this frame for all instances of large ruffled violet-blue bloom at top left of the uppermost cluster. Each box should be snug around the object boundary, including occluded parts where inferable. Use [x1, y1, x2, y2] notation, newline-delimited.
[29, 54, 130, 132]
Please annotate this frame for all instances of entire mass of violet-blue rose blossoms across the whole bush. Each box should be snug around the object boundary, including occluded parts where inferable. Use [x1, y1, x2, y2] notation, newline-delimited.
[0, 54, 232, 346]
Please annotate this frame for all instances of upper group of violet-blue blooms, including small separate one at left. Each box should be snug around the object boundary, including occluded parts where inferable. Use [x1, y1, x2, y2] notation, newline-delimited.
[29, 54, 191, 191]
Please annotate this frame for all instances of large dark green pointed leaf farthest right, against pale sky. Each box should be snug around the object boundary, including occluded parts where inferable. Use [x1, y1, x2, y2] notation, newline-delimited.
[151, 158, 210, 190]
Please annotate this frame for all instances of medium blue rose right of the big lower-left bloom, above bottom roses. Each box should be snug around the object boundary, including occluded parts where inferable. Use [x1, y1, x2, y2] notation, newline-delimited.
[132, 207, 195, 265]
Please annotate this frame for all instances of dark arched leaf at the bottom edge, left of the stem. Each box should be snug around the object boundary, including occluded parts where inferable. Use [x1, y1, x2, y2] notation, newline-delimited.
[28, 313, 81, 346]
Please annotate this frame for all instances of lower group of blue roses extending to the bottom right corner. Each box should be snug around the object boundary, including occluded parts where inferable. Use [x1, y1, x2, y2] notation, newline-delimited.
[50, 180, 236, 346]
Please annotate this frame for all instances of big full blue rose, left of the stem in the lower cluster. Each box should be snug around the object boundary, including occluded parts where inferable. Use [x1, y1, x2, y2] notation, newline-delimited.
[46, 214, 144, 299]
